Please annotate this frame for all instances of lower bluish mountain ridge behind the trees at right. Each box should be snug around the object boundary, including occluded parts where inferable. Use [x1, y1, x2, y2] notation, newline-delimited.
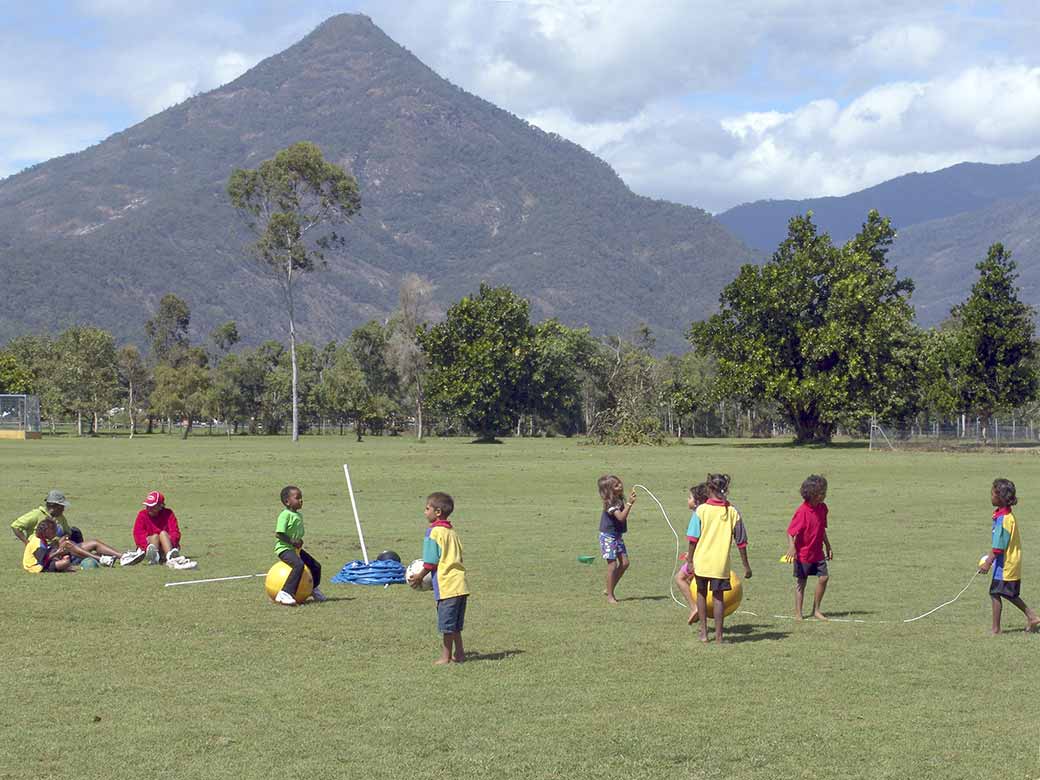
[717, 157, 1040, 326]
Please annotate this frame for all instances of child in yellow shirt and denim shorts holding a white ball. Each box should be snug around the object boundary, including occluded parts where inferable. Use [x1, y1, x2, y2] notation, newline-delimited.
[411, 493, 469, 666]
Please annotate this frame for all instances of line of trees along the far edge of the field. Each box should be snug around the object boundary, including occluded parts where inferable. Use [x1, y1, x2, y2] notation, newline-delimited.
[0, 212, 1038, 443]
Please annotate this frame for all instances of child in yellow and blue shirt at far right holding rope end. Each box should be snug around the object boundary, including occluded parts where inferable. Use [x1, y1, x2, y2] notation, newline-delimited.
[979, 478, 1040, 634]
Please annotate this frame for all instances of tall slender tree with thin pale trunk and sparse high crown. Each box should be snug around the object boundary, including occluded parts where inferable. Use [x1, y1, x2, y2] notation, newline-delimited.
[228, 141, 361, 441]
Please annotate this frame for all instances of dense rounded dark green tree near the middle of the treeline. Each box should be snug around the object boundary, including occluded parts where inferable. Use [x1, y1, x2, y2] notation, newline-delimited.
[420, 284, 535, 441]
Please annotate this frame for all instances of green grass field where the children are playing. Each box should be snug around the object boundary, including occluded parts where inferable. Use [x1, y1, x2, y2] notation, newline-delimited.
[0, 436, 1040, 780]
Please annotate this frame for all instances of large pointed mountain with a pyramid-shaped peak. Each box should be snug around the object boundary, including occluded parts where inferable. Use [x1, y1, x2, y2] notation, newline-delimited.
[0, 15, 751, 349]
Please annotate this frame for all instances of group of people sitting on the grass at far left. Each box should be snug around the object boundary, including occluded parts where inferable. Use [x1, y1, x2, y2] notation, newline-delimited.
[10, 490, 197, 573]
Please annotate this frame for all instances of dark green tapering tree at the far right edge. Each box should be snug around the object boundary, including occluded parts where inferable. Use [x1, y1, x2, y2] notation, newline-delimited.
[952, 243, 1037, 434]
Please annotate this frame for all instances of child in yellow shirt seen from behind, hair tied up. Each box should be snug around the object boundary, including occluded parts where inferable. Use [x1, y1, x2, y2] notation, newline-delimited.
[686, 474, 751, 645]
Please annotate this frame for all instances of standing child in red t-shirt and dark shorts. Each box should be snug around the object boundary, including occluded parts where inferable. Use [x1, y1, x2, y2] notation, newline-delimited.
[787, 474, 834, 620]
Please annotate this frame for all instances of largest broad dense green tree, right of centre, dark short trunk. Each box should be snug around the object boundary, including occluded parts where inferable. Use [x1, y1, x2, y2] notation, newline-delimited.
[688, 210, 919, 443]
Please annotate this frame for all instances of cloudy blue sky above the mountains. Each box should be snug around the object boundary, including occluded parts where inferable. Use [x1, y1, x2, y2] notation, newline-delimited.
[0, 0, 1040, 211]
